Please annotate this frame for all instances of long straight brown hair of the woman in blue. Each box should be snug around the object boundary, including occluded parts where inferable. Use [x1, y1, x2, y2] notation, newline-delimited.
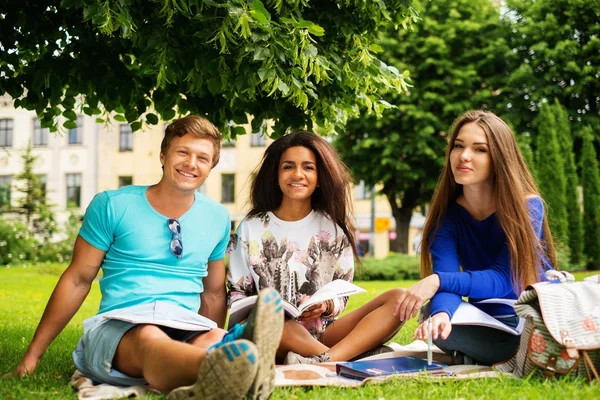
[421, 111, 557, 293]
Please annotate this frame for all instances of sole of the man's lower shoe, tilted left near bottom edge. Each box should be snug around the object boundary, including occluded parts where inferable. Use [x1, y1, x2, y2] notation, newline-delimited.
[167, 339, 260, 400]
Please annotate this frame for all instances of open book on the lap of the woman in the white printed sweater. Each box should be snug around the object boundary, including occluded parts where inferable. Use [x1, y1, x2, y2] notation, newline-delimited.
[229, 279, 366, 327]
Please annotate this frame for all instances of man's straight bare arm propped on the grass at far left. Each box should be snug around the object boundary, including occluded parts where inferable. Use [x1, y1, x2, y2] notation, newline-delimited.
[13, 236, 106, 376]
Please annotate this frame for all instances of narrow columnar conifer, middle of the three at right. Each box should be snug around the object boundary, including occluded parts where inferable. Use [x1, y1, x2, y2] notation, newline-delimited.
[552, 100, 583, 268]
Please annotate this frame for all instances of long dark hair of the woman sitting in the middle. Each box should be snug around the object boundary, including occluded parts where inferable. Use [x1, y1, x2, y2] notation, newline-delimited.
[248, 131, 358, 259]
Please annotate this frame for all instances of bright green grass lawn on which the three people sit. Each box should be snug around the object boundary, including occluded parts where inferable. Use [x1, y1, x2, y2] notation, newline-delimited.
[0, 264, 600, 400]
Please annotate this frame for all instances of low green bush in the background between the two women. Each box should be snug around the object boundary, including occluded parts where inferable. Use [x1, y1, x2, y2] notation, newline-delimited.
[354, 254, 421, 281]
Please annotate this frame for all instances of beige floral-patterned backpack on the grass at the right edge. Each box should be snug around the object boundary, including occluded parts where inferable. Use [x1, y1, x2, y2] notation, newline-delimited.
[494, 277, 600, 381]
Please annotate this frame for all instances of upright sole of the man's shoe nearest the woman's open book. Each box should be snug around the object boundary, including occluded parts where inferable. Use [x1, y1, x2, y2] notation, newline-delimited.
[242, 288, 284, 399]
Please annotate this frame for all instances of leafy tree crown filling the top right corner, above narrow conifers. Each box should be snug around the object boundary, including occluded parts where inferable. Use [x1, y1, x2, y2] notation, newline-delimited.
[503, 0, 600, 143]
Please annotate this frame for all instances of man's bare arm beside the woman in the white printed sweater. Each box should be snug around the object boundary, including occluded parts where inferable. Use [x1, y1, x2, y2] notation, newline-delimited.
[200, 260, 227, 328]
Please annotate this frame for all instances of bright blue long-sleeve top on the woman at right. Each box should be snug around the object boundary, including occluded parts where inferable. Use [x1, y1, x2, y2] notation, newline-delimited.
[430, 197, 552, 318]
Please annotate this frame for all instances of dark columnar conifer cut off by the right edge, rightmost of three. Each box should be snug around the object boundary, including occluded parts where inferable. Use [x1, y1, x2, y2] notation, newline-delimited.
[581, 128, 600, 269]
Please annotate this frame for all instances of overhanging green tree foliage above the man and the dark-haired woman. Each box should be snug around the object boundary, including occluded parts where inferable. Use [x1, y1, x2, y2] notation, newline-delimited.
[0, 0, 414, 136]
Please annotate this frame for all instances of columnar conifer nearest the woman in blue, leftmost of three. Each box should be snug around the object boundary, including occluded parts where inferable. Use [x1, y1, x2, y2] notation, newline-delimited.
[535, 103, 568, 244]
